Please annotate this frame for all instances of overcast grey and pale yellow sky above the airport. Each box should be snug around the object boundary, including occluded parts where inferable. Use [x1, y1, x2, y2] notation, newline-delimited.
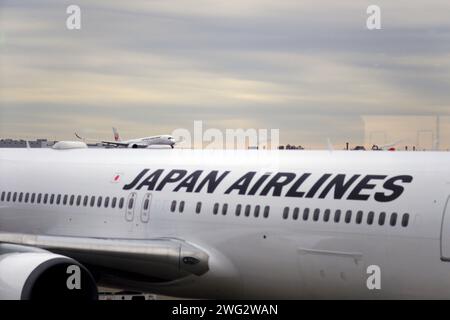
[0, 0, 450, 147]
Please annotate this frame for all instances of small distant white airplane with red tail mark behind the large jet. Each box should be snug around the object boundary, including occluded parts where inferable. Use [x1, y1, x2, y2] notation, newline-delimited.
[75, 128, 177, 149]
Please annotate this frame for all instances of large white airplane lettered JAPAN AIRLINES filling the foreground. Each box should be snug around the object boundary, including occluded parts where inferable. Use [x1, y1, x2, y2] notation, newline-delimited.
[0, 142, 450, 299]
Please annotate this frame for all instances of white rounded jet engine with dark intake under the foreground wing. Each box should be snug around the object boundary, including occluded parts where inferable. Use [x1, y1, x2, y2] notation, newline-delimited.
[0, 247, 98, 300]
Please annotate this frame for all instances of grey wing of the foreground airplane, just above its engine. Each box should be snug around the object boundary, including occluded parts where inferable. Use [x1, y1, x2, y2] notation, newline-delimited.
[0, 233, 209, 282]
